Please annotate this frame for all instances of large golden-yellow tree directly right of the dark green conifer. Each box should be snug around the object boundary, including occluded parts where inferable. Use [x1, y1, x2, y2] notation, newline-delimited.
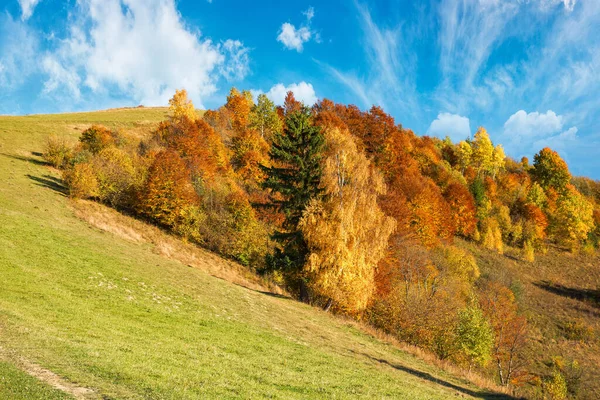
[300, 130, 395, 313]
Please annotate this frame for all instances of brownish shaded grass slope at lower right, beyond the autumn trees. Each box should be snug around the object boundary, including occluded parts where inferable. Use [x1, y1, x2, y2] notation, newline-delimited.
[458, 241, 600, 400]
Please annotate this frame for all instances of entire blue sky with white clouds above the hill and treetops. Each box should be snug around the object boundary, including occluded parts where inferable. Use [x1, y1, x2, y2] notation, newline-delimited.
[0, 0, 600, 179]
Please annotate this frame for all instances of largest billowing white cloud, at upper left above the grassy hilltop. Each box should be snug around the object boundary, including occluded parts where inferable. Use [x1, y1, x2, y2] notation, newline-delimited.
[42, 0, 248, 107]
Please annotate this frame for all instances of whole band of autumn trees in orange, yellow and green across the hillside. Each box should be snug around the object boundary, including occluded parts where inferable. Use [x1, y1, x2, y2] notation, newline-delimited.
[46, 89, 600, 393]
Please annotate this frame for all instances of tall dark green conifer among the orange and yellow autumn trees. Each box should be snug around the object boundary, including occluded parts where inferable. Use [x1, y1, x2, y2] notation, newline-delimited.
[263, 106, 324, 282]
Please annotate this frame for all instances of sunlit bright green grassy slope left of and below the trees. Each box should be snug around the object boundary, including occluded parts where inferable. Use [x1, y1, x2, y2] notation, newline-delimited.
[0, 109, 510, 399]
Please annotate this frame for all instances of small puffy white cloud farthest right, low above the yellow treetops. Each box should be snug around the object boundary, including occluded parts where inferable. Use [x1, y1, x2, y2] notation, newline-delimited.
[504, 110, 563, 138]
